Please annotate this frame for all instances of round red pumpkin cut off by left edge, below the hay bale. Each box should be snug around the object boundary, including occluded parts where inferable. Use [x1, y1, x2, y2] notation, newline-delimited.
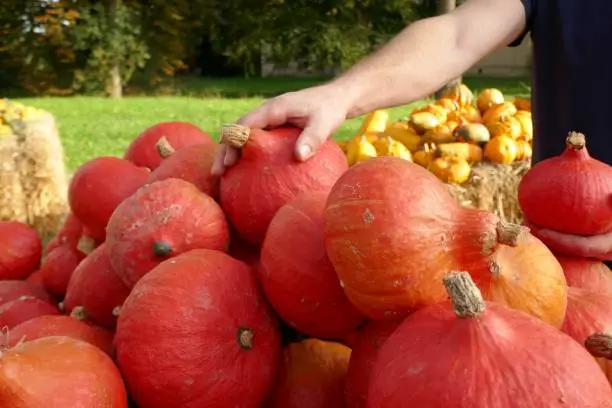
[0, 221, 42, 280]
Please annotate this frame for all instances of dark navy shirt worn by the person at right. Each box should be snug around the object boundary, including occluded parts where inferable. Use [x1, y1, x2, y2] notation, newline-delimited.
[510, 0, 612, 165]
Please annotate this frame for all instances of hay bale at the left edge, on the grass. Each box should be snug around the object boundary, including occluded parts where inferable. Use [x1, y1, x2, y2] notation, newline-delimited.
[0, 108, 68, 239]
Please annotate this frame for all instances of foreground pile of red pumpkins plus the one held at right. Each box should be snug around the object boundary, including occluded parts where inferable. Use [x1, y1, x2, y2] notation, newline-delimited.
[0, 122, 612, 408]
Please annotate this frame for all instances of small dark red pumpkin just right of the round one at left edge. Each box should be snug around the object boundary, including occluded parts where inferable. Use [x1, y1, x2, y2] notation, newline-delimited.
[40, 243, 85, 297]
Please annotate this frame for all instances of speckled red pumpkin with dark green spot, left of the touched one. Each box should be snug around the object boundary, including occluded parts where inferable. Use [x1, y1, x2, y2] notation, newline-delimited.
[106, 179, 229, 288]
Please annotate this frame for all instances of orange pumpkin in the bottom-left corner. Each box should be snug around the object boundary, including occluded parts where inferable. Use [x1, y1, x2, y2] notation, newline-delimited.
[0, 336, 128, 408]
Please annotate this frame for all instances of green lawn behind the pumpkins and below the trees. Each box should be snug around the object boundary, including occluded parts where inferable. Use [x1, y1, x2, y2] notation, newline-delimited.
[15, 77, 528, 171]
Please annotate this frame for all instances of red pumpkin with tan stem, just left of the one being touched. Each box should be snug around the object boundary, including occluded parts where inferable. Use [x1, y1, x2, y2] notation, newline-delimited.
[149, 138, 219, 200]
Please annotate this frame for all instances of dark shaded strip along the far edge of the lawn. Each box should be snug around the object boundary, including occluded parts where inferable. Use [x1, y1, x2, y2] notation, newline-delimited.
[5, 76, 530, 99]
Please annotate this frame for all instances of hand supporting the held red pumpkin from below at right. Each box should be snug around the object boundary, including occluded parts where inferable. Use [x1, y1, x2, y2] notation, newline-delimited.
[523, 220, 612, 261]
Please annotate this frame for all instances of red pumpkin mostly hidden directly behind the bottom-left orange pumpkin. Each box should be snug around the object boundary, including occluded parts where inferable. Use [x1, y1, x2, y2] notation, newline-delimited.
[9, 315, 114, 356]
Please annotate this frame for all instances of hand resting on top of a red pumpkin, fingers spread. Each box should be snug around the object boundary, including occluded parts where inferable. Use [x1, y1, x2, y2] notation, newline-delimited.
[211, 83, 351, 176]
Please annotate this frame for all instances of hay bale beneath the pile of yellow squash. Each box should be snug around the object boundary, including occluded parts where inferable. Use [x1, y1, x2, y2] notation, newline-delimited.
[449, 161, 531, 223]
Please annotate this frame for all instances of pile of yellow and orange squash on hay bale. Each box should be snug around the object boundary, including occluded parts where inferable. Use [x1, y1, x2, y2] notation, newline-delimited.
[338, 84, 533, 184]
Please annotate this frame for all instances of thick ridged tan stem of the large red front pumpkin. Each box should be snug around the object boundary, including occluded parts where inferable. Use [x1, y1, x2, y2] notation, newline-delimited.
[442, 272, 486, 318]
